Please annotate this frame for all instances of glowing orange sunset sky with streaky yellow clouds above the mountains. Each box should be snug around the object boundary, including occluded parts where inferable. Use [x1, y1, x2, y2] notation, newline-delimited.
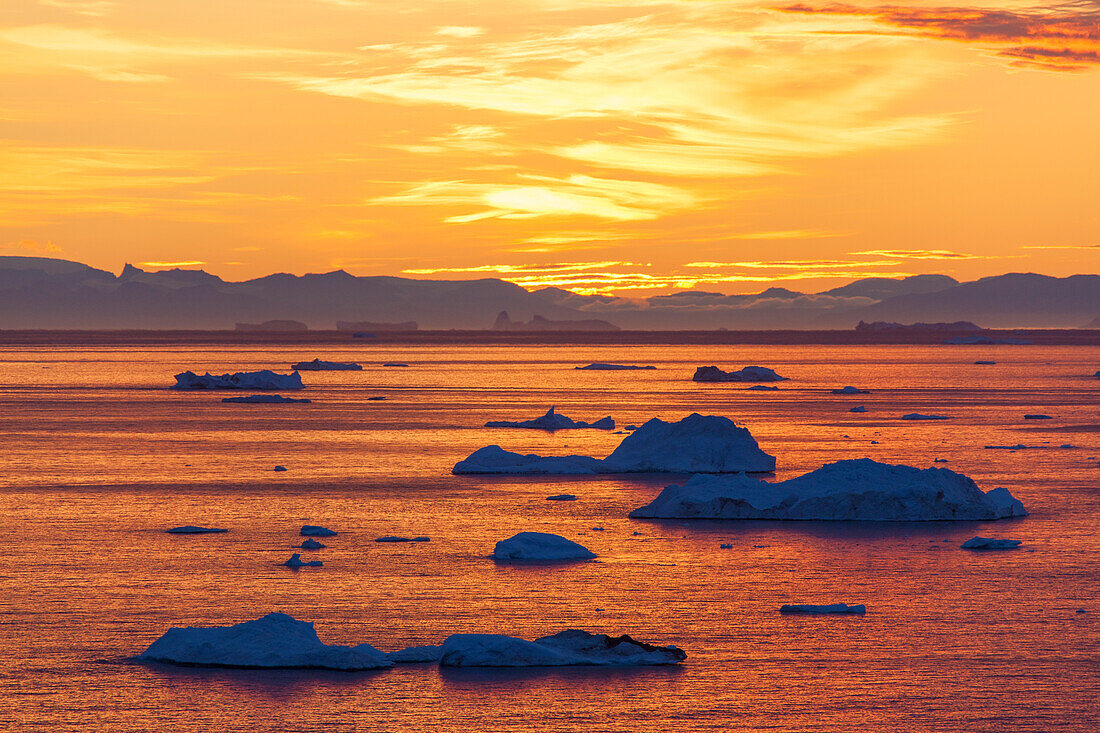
[0, 0, 1100, 297]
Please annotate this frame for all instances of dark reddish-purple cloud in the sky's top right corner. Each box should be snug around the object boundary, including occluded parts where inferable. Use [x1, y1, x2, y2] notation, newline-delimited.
[780, 1, 1100, 72]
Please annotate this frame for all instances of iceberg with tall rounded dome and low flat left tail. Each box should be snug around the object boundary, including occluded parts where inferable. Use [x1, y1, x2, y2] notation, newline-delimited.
[452, 413, 776, 475]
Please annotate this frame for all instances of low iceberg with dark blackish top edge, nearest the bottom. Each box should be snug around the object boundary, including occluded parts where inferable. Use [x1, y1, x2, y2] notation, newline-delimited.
[439, 630, 688, 667]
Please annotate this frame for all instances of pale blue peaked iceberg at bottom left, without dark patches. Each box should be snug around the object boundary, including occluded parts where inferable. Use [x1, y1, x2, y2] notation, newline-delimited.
[135, 613, 393, 671]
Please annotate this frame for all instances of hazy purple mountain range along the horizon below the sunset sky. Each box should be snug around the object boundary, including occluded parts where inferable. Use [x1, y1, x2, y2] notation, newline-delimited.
[0, 256, 1100, 330]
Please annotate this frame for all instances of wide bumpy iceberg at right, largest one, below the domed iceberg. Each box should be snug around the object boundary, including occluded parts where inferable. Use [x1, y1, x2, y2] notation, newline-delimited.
[630, 458, 1027, 522]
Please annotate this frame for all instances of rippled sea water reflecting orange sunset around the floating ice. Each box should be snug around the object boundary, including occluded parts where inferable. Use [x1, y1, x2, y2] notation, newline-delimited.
[0, 344, 1100, 732]
